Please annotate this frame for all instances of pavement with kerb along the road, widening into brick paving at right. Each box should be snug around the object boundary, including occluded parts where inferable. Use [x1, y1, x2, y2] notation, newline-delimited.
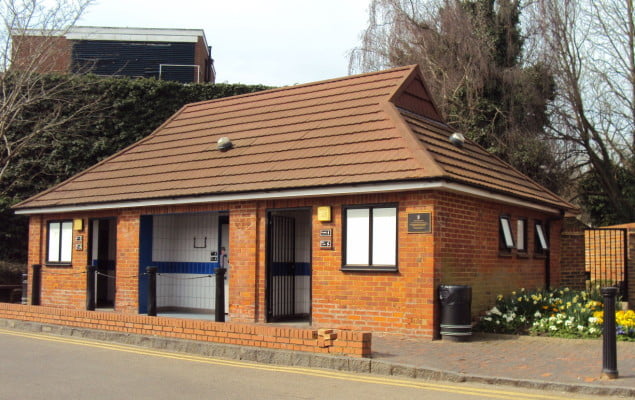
[0, 319, 635, 398]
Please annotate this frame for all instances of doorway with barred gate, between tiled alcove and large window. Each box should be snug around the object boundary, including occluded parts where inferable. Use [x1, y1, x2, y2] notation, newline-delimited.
[266, 209, 311, 322]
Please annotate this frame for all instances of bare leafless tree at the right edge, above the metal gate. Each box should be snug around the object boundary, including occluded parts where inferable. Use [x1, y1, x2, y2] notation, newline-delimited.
[533, 0, 635, 222]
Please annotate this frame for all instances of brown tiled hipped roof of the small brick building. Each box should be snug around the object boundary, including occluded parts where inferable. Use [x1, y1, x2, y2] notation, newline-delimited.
[16, 66, 572, 209]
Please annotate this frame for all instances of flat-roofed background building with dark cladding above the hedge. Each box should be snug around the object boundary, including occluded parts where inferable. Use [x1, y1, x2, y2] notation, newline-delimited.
[13, 26, 216, 83]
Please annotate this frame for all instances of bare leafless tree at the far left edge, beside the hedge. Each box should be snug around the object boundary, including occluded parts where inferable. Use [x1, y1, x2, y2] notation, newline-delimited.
[0, 0, 92, 186]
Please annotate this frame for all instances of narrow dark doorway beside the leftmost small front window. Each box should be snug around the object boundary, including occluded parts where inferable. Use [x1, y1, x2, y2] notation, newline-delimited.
[90, 218, 117, 308]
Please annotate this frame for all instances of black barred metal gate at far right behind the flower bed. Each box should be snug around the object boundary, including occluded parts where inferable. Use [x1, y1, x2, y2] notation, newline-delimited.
[584, 228, 628, 300]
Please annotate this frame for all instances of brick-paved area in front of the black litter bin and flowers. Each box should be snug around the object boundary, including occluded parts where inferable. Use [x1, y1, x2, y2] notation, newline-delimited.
[372, 333, 635, 390]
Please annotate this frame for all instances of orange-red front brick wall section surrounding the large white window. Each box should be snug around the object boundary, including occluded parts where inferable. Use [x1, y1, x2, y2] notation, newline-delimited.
[312, 192, 434, 337]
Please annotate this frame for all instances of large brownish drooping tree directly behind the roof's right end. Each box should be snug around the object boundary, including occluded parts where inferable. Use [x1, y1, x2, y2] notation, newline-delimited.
[349, 0, 567, 192]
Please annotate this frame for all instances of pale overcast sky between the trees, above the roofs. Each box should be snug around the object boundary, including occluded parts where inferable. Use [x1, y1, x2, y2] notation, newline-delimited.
[77, 0, 369, 86]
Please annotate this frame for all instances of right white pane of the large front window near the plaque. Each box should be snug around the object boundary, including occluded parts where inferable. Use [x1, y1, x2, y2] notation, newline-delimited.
[373, 208, 397, 265]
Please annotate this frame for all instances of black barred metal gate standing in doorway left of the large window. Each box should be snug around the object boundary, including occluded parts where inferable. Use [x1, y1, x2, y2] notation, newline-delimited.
[266, 214, 296, 322]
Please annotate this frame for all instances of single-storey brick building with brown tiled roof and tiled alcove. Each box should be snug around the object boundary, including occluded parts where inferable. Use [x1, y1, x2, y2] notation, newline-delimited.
[16, 66, 575, 337]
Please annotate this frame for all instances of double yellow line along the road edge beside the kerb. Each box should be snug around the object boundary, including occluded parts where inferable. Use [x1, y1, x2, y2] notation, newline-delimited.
[0, 329, 570, 400]
